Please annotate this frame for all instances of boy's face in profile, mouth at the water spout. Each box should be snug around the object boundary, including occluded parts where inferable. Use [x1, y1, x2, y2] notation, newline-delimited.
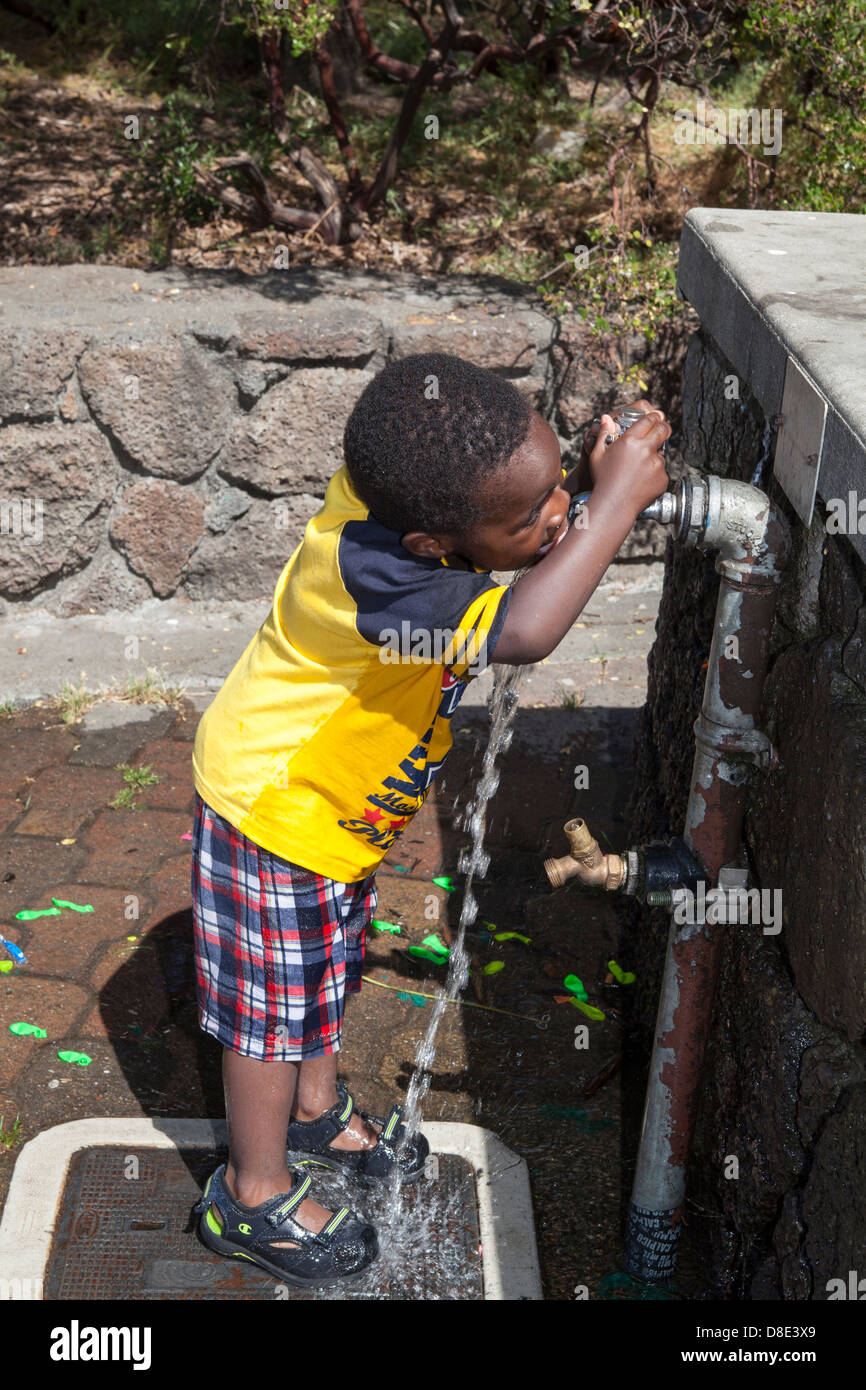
[402, 411, 571, 570]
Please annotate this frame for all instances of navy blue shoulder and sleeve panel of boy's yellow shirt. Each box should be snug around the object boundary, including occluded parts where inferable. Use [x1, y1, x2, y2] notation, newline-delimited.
[338, 517, 512, 660]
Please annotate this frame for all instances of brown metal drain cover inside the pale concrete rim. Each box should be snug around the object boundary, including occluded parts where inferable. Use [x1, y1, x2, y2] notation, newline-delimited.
[44, 1147, 484, 1301]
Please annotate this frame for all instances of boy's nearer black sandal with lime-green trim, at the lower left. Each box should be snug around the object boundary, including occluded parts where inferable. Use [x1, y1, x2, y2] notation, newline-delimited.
[193, 1163, 379, 1289]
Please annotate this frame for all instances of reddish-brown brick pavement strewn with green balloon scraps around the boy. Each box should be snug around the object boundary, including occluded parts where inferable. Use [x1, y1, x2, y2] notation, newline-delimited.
[0, 566, 683, 1300]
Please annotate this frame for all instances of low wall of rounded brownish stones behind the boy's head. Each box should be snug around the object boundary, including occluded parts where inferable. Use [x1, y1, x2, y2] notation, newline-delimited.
[0, 265, 692, 616]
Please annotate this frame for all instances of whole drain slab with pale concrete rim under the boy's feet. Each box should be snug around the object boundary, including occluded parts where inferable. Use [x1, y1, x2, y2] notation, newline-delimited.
[0, 1119, 542, 1301]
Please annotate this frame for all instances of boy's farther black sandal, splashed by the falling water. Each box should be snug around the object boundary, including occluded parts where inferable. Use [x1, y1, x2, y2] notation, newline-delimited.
[286, 1081, 430, 1184]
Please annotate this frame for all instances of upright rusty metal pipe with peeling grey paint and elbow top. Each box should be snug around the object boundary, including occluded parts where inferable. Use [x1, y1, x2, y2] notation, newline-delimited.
[624, 477, 790, 1283]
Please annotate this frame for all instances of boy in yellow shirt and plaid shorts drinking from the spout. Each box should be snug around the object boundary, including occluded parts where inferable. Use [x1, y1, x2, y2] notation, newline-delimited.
[192, 353, 670, 1286]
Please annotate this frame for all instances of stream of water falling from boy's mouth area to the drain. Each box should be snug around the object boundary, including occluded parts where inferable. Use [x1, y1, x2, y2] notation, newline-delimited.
[379, 666, 525, 1259]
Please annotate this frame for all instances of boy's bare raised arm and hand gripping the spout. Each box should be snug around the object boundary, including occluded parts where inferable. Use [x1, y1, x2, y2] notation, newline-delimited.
[492, 413, 670, 666]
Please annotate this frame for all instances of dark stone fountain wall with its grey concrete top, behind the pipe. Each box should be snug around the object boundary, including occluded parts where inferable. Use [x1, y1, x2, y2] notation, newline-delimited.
[628, 210, 866, 1300]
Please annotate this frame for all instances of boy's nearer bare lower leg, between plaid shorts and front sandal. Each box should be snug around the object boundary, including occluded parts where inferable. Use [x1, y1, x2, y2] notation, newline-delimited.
[222, 1048, 336, 1247]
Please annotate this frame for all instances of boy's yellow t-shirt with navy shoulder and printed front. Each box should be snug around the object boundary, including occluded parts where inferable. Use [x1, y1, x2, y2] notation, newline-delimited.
[193, 466, 512, 883]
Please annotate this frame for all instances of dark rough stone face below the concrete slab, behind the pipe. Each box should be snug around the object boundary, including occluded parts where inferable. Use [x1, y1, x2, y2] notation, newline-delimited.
[626, 322, 866, 1300]
